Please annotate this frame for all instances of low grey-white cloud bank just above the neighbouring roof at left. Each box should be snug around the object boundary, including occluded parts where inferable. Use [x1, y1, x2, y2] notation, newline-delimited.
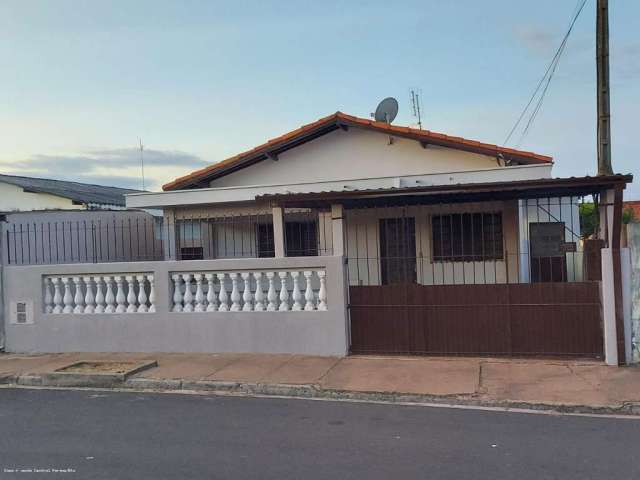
[0, 148, 208, 190]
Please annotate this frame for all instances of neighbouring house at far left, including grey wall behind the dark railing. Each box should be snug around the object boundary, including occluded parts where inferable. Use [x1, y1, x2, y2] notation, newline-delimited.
[0, 175, 164, 265]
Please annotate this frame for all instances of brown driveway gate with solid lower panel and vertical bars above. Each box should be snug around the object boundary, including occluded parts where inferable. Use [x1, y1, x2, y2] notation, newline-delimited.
[345, 197, 603, 358]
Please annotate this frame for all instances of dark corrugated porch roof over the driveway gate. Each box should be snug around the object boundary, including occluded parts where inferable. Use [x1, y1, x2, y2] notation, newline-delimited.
[256, 174, 633, 207]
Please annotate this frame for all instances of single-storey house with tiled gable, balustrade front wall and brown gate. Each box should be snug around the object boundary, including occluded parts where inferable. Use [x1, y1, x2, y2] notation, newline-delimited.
[1, 112, 632, 364]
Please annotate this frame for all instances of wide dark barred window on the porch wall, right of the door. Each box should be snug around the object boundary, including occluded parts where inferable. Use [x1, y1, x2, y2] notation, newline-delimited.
[431, 212, 504, 262]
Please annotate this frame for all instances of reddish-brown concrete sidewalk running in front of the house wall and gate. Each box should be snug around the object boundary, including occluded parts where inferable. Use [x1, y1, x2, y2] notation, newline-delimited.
[0, 353, 640, 413]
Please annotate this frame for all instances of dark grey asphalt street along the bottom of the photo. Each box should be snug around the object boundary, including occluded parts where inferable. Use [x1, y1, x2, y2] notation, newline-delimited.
[0, 389, 640, 480]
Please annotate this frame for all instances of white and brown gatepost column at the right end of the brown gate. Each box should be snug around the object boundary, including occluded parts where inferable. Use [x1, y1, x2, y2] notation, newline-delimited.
[599, 185, 626, 365]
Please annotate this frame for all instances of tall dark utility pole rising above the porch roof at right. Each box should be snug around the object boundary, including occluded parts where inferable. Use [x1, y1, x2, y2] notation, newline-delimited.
[596, 0, 613, 175]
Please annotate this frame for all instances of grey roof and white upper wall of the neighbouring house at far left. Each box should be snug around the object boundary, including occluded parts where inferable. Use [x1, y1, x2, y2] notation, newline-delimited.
[0, 174, 139, 212]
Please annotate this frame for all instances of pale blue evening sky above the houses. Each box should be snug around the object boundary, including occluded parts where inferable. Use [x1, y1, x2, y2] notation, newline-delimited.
[0, 0, 640, 195]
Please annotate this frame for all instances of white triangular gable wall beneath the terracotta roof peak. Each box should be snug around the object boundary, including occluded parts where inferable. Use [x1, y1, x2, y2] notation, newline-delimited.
[210, 128, 544, 187]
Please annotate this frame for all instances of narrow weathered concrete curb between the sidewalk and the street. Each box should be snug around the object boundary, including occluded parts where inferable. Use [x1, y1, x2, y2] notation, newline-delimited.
[6, 374, 640, 416]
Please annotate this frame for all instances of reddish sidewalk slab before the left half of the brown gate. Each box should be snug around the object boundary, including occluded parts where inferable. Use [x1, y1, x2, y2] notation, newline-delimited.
[320, 357, 480, 395]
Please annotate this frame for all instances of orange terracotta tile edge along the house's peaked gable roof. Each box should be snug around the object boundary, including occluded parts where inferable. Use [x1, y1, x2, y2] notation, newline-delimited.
[162, 112, 552, 190]
